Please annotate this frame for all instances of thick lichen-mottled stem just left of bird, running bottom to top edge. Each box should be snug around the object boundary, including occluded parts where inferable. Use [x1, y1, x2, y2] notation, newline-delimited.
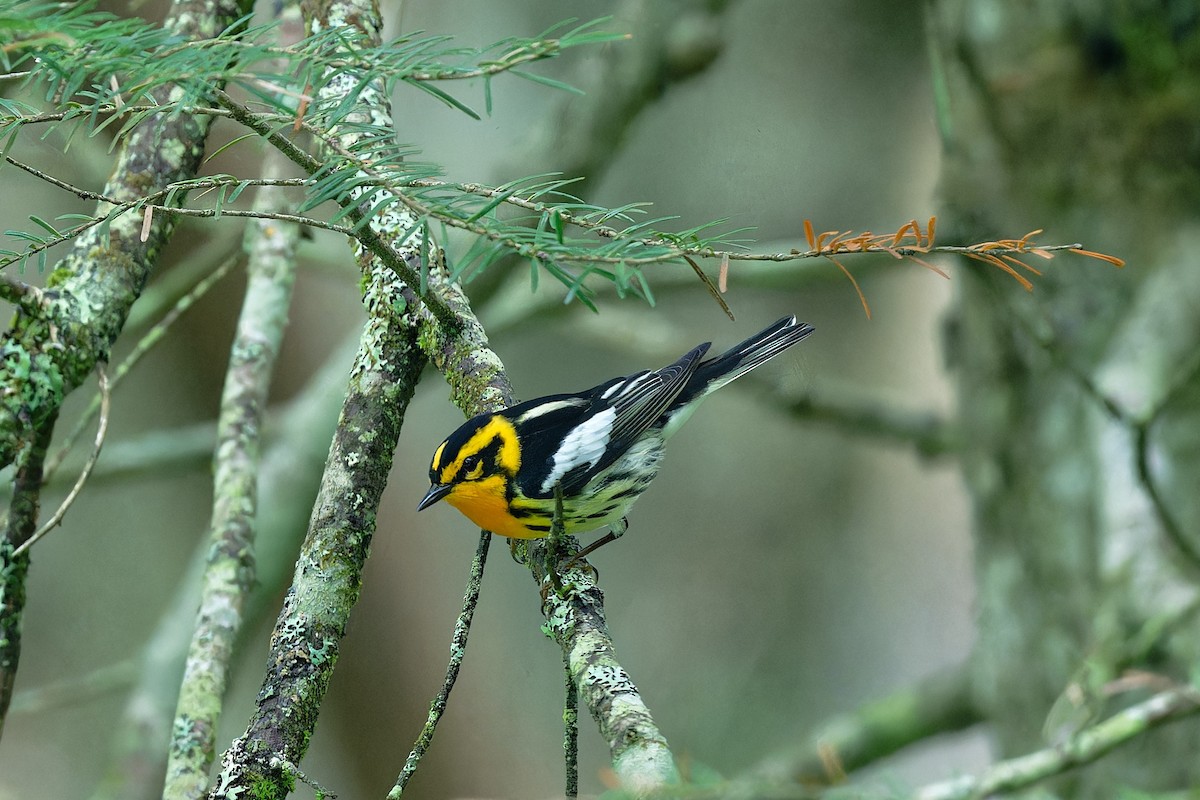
[210, 0, 425, 798]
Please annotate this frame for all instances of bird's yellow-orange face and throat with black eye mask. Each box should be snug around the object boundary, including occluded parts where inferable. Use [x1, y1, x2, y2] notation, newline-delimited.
[416, 415, 530, 539]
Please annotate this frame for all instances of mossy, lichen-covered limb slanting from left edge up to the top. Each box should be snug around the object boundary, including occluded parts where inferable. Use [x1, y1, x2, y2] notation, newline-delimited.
[0, 0, 250, 467]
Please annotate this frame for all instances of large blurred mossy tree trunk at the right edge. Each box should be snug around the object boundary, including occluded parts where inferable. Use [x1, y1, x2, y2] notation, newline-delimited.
[932, 0, 1200, 796]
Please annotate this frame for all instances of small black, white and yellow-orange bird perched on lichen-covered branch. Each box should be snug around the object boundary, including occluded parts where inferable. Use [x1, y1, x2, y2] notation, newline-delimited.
[416, 315, 814, 560]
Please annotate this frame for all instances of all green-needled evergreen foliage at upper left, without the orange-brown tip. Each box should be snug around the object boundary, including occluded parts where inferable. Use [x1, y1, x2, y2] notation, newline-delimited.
[0, 0, 739, 316]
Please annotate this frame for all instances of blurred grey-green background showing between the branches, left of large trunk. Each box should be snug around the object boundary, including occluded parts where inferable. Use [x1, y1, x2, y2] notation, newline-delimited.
[0, 0, 984, 799]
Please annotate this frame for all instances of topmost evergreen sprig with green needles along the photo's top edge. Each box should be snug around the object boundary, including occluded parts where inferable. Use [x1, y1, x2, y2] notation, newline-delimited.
[7, 0, 625, 119]
